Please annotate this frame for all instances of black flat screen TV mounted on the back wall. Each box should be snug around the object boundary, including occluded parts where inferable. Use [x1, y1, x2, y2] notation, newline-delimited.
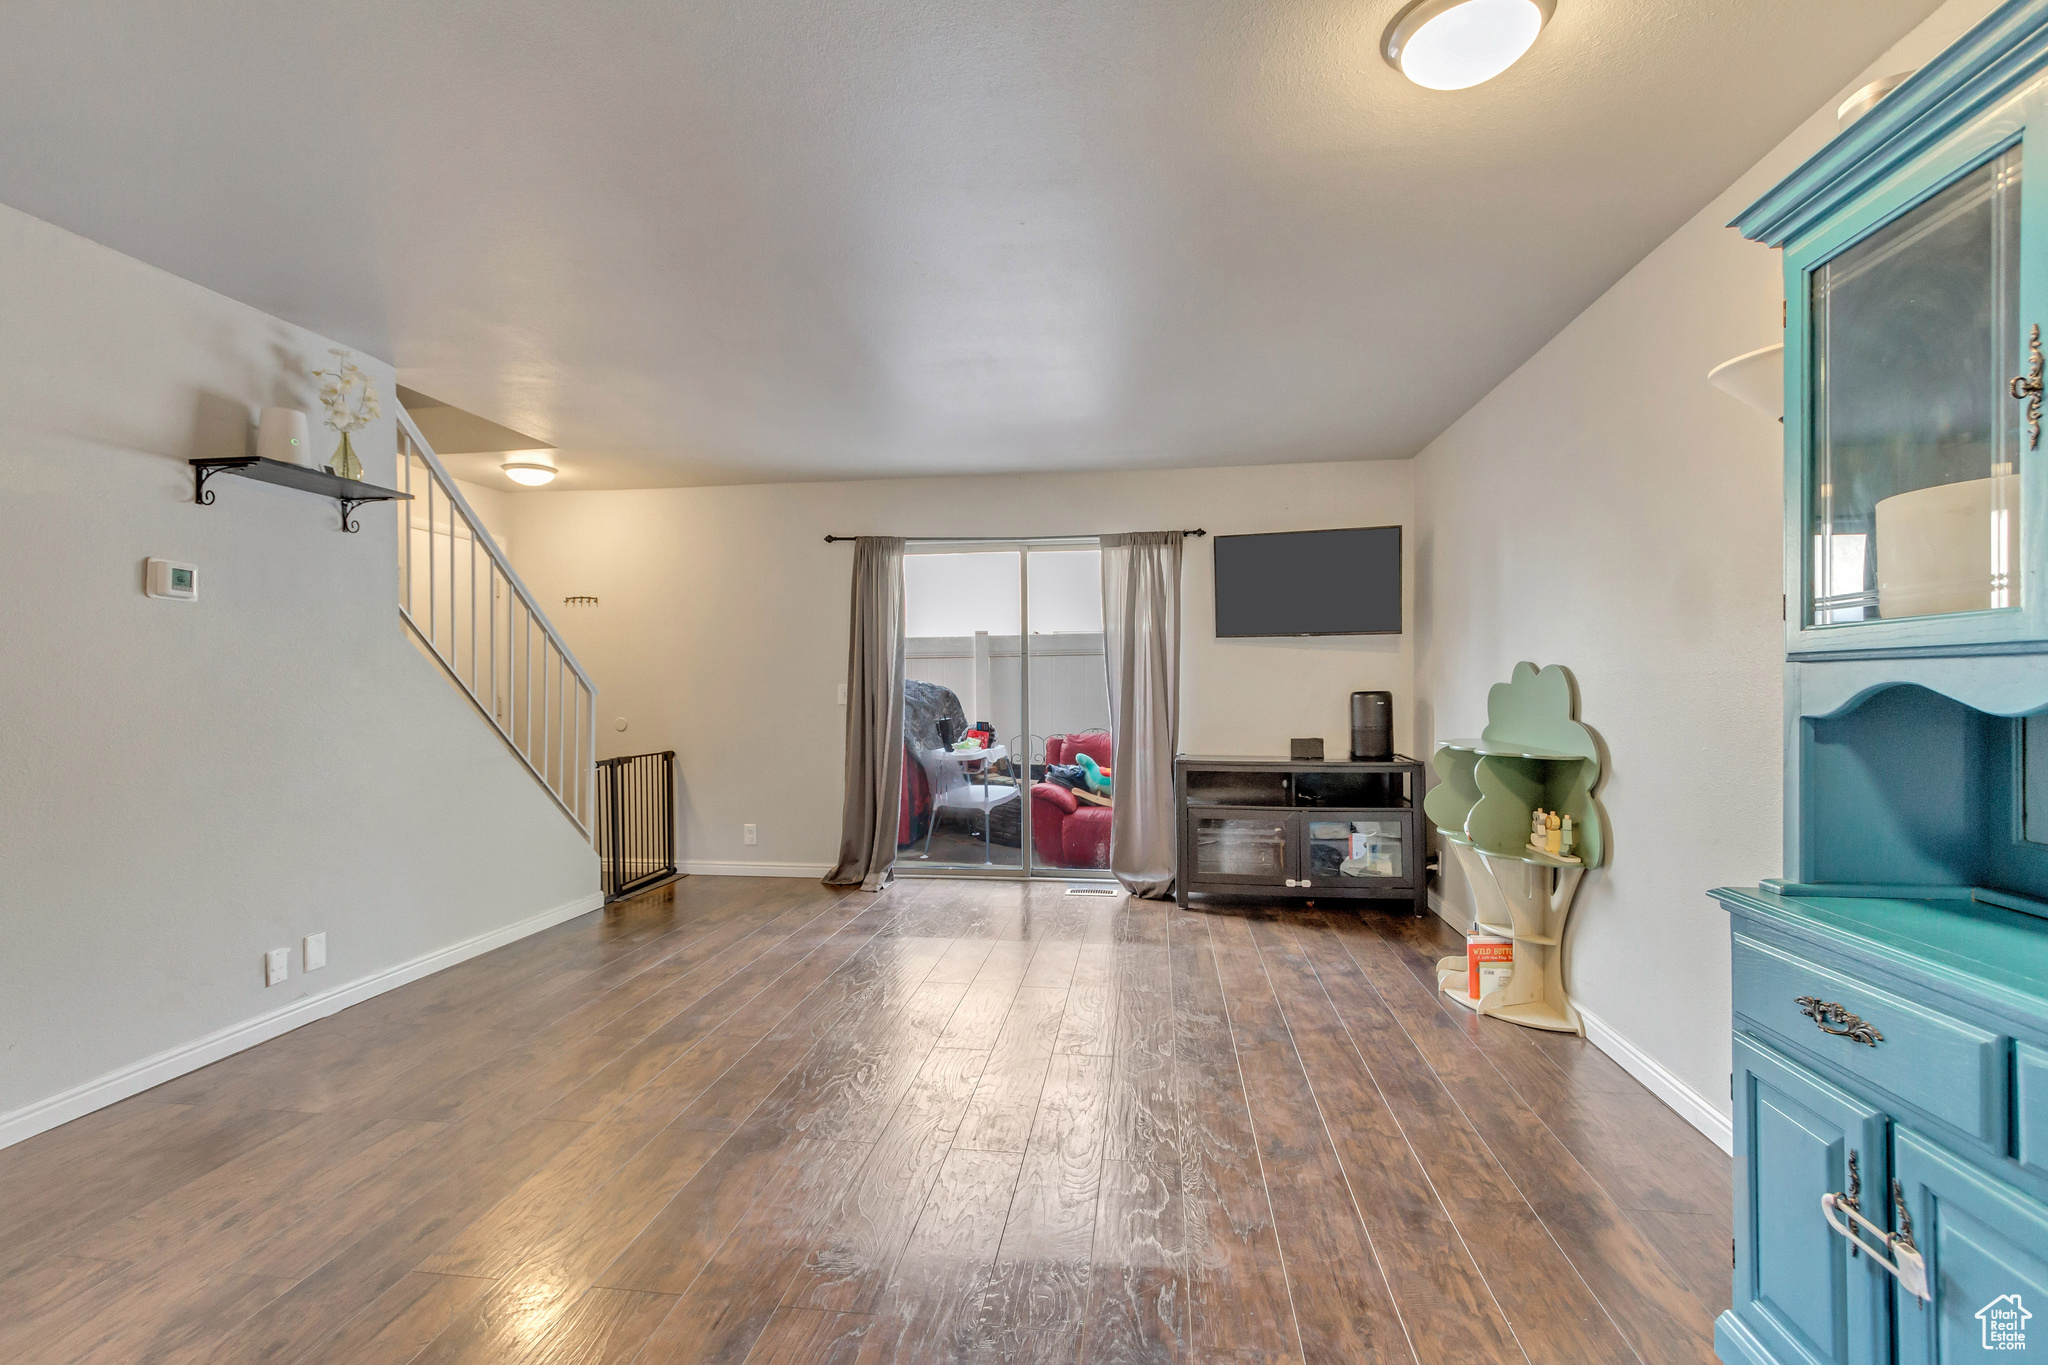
[1217, 526, 1401, 639]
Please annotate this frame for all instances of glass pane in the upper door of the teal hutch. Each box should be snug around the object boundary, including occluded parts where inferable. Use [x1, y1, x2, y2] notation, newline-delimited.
[1806, 147, 2030, 626]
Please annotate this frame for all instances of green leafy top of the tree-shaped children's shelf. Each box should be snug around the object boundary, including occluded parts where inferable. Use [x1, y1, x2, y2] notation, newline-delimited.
[1423, 663, 1606, 868]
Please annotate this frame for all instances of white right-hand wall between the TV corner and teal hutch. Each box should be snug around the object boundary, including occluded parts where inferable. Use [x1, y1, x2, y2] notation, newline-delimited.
[1413, 0, 1991, 1136]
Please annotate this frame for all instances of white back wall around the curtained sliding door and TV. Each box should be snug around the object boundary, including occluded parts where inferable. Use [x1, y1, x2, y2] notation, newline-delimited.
[508, 463, 1413, 872]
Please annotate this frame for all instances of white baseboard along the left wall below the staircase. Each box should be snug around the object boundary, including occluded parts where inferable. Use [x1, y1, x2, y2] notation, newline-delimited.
[0, 890, 604, 1148]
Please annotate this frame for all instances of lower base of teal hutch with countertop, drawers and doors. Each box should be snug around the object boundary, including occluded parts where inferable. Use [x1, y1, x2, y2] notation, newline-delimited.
[1714, 884, 2048, 1365]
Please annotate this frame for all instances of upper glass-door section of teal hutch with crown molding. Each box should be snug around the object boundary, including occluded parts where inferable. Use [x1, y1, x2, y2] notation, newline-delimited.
[1735, 0, 2048, 657]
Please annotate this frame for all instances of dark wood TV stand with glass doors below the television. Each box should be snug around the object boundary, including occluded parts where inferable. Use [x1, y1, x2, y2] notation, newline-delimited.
[1174, 753, 1430, 915]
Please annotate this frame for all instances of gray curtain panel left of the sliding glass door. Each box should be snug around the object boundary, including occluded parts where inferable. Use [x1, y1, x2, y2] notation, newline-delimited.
[825, 536, 903, 890]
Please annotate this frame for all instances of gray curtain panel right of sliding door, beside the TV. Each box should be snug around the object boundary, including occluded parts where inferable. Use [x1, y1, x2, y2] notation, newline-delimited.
[1102, 530, 1182, 898]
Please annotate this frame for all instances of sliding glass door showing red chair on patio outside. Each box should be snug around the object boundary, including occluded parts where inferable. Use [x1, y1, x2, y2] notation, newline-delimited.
[897, 538, 1114, 878]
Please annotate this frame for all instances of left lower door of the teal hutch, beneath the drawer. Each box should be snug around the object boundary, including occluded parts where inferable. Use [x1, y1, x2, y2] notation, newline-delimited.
[1720, 1038, 1890, 1365]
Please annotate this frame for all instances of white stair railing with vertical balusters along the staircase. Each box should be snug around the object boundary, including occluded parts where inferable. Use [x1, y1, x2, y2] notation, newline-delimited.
[391, 409, 598, 839]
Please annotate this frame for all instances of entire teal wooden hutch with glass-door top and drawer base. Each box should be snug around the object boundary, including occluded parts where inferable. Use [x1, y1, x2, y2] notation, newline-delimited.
[1714, 0, 2048, 1365]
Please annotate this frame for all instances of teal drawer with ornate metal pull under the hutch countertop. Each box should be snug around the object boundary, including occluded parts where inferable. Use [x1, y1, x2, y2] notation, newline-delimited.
[1735, 933, 2005, 1150]
